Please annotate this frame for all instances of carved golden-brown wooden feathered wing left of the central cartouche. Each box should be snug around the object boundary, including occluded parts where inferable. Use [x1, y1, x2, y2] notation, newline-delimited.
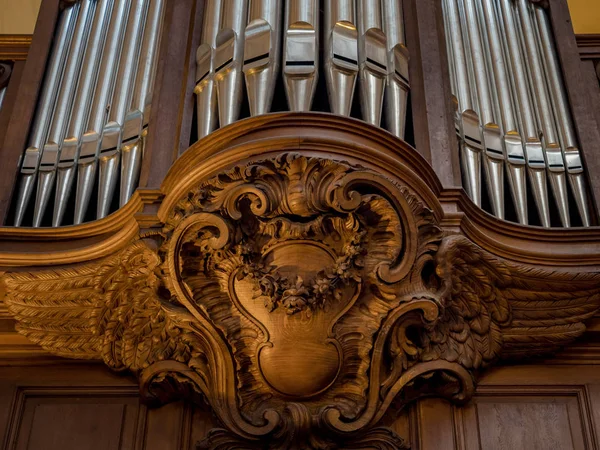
[5, 242, 189, 371]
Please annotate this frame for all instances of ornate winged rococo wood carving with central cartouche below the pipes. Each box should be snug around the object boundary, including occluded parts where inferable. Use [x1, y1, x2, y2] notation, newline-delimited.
[4, 151, 600, 449]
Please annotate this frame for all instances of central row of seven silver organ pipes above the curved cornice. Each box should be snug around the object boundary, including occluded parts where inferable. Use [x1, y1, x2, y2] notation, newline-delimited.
[195, 0, 409, 138]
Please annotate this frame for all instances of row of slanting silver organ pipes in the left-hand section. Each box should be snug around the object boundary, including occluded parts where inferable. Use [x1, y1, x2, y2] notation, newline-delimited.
[15, 0, 166, 227]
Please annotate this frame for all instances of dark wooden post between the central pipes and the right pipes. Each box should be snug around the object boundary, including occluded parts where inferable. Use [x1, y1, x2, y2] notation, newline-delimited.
[404, 0, 462, 188]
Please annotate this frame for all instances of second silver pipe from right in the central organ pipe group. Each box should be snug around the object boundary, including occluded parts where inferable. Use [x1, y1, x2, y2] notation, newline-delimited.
[357, 0, 388, 126]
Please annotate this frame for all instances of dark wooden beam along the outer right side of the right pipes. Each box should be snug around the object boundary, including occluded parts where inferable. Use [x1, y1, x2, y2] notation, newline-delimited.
[548, 0, 600, 221]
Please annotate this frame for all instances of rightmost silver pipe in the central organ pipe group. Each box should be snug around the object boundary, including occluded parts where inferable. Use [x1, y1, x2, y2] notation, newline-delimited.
[383, 0, 410, 139]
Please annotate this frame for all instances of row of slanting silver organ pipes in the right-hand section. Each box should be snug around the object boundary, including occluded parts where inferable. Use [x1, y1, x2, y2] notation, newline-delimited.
[443, 0, 590, 227]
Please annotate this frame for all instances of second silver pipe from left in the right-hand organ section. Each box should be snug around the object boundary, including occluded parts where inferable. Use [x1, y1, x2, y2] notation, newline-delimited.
[463, 0, 506, 219]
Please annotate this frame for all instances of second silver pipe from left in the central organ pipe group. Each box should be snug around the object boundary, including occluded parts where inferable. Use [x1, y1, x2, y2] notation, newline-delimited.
[215, 0, 248, 127]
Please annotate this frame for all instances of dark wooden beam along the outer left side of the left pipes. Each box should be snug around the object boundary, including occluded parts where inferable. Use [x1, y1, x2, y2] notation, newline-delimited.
[0, 0, 60, 224]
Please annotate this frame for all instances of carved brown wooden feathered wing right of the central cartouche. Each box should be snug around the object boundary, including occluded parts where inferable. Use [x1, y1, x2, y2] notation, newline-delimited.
[421, 236, 600, 369]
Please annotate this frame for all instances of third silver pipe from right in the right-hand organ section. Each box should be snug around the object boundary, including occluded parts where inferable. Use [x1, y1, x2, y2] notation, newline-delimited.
[498, 0, 550, 227]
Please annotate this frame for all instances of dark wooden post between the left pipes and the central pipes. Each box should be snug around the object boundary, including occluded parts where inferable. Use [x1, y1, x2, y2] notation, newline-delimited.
[140, 0, 204, 188]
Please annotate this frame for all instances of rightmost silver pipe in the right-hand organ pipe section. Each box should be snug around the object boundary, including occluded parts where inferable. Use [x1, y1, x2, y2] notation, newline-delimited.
[531, 5, 591, 227]
